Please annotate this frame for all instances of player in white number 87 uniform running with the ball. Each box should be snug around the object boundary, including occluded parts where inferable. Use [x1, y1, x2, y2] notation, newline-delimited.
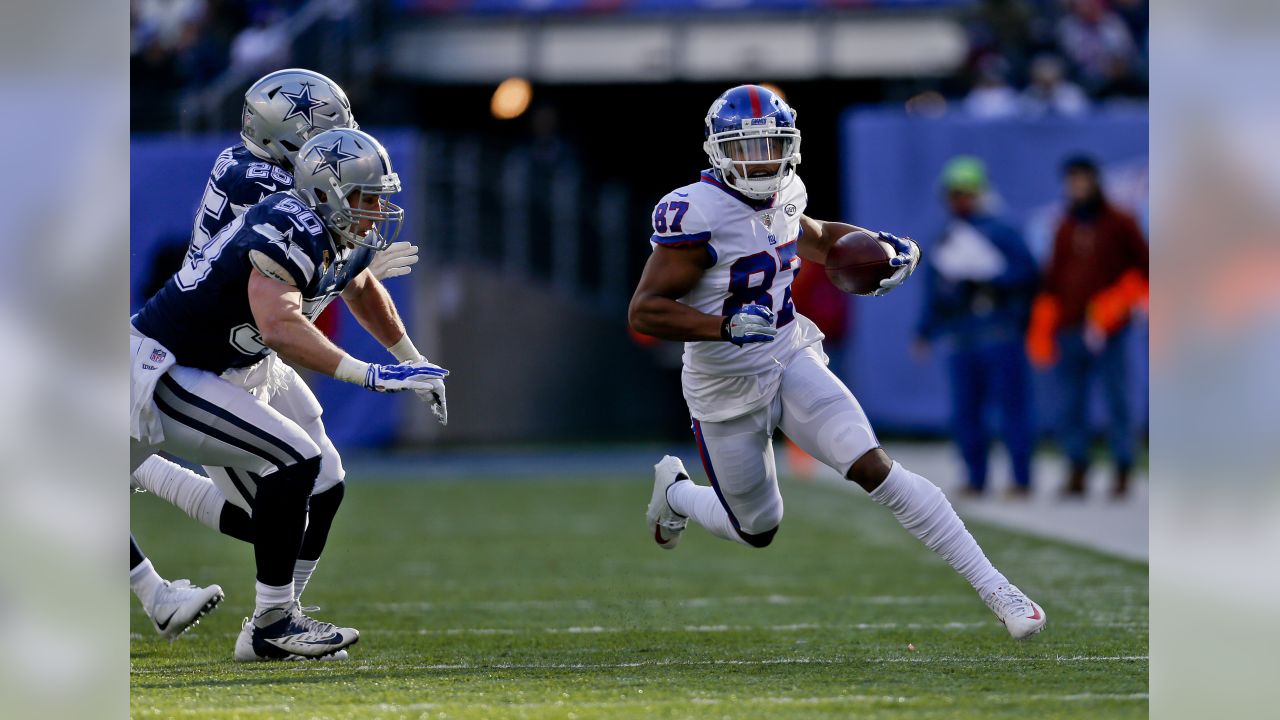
[630, 85, 1044, 639]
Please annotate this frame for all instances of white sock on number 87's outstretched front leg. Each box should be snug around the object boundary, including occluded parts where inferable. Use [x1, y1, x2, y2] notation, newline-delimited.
[872, 462, 1009, 600]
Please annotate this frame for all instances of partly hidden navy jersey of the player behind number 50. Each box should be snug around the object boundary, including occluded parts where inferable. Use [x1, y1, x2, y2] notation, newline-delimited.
[191, 142, 293, 250]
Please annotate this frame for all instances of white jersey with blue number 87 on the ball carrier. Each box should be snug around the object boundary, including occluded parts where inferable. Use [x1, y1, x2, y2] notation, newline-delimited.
[650, 170, 822, 377]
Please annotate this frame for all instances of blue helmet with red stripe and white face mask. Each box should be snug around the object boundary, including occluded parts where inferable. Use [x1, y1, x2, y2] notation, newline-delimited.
[703, 85, 800, 200]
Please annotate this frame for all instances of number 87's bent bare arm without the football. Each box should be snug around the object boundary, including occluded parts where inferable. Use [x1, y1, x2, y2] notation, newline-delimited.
[627, 246, 724, 341]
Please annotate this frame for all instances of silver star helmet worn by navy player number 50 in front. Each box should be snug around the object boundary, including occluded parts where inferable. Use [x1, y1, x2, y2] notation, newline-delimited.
[293, 128, 404, 250]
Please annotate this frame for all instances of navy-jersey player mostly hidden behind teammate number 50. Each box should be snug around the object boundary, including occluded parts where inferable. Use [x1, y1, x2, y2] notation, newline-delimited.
[129, 69, 417, 640]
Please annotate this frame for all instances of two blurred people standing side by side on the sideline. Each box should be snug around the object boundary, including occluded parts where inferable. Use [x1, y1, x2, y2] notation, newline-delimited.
[916, 155, 1148, 498]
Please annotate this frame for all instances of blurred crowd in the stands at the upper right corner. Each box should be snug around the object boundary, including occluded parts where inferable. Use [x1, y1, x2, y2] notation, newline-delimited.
[956, 0, 1149, 118]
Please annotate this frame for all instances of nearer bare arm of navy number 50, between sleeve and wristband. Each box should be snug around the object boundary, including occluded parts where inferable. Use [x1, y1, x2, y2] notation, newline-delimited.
[248, 269, 346, 375]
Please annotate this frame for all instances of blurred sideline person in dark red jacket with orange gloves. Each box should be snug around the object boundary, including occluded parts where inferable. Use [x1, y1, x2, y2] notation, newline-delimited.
[1027, 155, 1147, 497]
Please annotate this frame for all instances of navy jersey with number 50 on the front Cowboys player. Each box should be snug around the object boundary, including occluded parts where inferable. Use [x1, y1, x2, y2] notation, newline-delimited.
[133, 192, 374, 373]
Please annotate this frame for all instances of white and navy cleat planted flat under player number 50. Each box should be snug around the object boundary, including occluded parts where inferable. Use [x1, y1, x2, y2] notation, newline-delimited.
[236, 602, 360, 662]
